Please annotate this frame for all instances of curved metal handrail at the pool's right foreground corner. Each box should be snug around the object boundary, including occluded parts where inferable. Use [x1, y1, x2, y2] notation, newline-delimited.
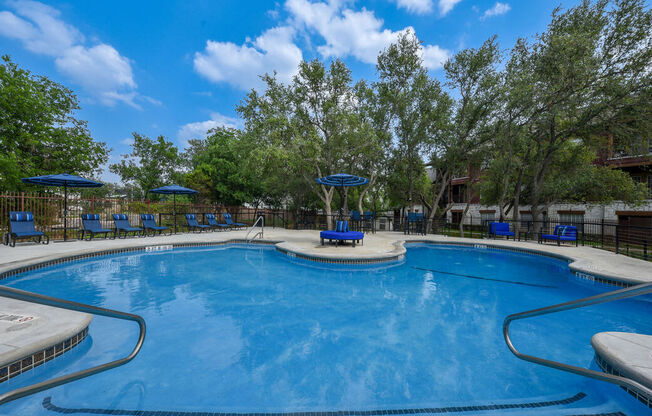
[503, 283, 652, 397]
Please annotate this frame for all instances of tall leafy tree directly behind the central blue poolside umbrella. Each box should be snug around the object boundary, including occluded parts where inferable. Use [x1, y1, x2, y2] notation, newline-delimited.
[238, 60, 377, 227]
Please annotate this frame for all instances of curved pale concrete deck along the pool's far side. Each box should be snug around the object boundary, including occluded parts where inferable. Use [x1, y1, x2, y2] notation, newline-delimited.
[0, 229, 652, 287]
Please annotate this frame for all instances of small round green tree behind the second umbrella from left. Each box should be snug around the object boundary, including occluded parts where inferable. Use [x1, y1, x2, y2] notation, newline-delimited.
[109, 133, 183, 199]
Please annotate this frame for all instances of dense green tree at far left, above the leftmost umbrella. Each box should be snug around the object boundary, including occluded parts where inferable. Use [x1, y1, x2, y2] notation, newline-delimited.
[0, 56, 110, 190]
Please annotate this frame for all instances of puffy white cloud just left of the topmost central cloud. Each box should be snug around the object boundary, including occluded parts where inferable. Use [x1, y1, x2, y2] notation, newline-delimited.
[194, 26, 303, 90]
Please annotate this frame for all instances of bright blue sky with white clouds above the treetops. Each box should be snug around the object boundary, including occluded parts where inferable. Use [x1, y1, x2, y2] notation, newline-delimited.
[0, 0, 577, 181]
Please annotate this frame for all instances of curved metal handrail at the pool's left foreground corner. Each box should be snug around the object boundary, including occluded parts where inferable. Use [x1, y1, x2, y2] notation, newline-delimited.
[0, 286, 146, 405]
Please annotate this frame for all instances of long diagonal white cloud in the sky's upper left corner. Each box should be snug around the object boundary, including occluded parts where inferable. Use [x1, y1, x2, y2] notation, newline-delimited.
[0, 1, 156, 108]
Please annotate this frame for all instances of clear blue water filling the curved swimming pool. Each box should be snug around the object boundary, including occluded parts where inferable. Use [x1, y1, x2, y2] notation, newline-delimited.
[0, 245, 652, 415]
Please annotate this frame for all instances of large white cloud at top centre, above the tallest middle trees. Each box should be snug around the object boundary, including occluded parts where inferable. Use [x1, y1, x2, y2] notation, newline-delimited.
[285, 0, 448, 69]
